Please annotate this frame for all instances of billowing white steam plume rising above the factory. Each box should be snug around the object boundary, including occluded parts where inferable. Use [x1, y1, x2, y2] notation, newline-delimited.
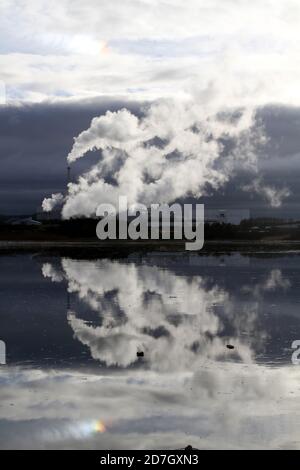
[43, 93, 286, 218]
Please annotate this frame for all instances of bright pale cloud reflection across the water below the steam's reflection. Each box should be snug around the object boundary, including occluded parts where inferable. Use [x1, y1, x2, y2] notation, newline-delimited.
[0, 362, 300, 449]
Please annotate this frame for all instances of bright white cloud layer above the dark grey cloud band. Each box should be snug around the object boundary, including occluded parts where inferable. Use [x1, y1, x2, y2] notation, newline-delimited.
[0, 0, 300, 105]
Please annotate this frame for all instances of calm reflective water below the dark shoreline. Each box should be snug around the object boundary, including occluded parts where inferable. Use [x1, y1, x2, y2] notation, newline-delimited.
[0, 253, 300, 449]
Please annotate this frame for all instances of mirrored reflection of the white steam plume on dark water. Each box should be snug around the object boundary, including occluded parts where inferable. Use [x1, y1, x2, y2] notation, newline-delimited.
[43, 259, 288, 371]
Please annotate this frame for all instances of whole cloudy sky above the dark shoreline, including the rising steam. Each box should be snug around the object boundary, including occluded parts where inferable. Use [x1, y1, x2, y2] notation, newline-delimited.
[0, 0, 300, 217]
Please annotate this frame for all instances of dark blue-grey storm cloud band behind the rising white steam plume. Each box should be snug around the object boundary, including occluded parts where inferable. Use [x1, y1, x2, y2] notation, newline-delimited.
[0, 98, 300, 216]
